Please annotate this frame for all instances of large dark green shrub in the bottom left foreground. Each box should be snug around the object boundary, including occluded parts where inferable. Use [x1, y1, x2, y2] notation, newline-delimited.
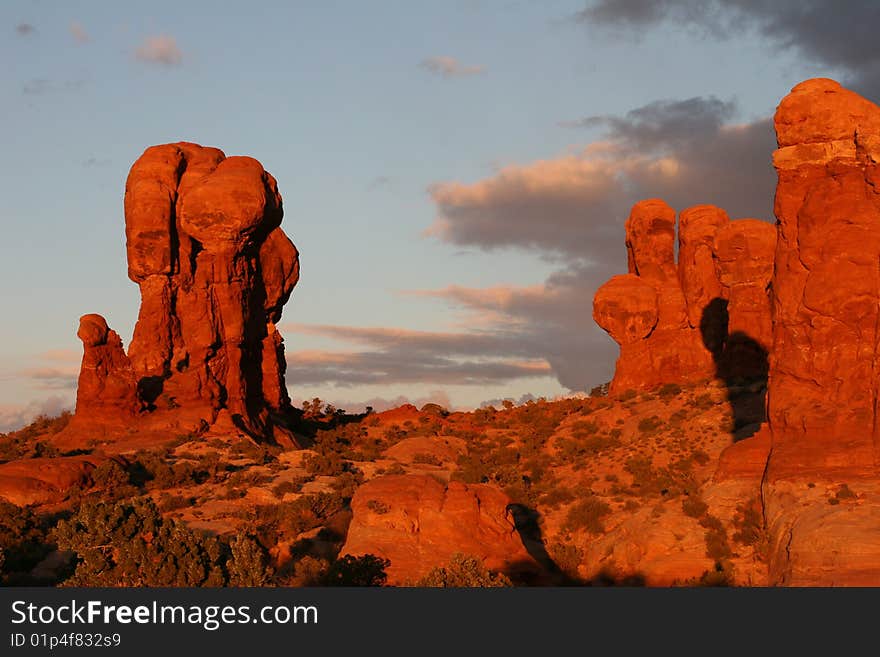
[54, 498, 254, 586]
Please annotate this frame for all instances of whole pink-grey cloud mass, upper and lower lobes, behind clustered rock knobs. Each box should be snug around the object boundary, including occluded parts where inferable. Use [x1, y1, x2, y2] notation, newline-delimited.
[426, 97, 776, 391]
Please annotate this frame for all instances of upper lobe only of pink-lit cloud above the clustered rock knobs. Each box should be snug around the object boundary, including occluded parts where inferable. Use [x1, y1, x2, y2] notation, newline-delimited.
[426, 97, 775, 260]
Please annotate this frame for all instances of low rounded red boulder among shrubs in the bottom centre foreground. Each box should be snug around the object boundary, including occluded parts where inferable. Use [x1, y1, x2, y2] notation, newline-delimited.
[340, 475, 538, 584]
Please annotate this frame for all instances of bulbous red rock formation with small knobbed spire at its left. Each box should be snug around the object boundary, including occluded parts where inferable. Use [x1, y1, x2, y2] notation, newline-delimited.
[63, 142, 299, 441]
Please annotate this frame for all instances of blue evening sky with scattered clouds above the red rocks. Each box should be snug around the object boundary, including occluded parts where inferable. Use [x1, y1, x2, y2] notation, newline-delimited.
[0, 0, 880, 431]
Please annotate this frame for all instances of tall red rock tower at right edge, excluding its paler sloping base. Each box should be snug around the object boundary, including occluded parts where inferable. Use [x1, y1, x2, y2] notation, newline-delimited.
[768, 79, 880, 479]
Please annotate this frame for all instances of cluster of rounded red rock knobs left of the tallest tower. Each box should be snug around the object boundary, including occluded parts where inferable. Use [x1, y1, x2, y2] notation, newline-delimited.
[593, 199, 775, 392]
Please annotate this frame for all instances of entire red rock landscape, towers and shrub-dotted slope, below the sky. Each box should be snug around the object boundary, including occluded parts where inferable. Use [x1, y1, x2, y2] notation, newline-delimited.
[0, 79, 880, 586]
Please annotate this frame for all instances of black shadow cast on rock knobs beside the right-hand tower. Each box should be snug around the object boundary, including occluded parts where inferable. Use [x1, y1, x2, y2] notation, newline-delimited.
[700, 298, 770, 442]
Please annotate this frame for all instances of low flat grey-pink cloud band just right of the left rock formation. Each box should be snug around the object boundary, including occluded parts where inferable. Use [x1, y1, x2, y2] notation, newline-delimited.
[280, 324, 552, 387]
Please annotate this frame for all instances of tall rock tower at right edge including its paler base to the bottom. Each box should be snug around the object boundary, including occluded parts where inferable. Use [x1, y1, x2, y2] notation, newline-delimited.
[762, 79, 880, 585]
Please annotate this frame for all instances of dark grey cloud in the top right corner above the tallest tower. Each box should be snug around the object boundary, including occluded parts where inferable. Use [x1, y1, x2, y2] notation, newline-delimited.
[577, 0, 880, 98]
